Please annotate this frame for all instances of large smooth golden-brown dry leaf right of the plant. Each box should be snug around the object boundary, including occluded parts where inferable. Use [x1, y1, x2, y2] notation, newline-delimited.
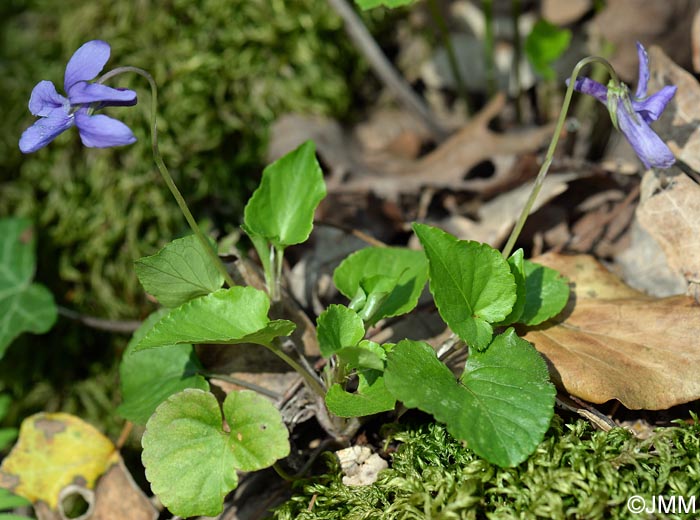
[524, 253, 700, 410]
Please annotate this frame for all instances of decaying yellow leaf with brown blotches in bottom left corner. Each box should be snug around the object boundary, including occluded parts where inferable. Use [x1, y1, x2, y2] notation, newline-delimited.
[0, 413, 119, 509]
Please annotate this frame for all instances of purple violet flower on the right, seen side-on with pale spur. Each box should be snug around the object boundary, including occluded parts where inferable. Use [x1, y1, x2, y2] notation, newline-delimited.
[567, 42, 677, 168]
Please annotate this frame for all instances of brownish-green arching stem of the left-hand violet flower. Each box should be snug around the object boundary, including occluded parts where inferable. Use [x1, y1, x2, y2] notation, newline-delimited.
[97, 66, 236, 287]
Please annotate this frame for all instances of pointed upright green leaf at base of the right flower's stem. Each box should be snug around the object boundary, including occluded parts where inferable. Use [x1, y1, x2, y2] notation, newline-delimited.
[413, 224, 516, 350]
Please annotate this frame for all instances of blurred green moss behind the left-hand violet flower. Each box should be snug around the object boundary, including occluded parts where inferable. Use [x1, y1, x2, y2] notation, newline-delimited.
[0, 0, 366, 317]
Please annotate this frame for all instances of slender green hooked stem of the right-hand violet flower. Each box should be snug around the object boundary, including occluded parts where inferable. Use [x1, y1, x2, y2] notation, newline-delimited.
[502, 56, 620, 258]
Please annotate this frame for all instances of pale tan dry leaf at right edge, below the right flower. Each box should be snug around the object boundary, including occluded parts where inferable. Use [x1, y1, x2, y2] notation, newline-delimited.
[637, 172, 700, 292]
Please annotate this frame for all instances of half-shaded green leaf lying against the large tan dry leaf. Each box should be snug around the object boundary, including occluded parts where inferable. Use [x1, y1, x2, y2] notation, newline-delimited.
[518, 260, 569, 325]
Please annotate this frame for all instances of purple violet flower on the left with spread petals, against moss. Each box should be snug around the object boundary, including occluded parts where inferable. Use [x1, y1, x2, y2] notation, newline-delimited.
[19, 40, 136, 153]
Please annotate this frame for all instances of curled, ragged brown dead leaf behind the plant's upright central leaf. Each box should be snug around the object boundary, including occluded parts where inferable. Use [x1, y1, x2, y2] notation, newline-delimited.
[268, 95, 554, 200]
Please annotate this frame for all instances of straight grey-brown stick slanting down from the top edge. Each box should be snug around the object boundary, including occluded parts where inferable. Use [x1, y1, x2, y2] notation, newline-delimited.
[328, 0, 447, 141]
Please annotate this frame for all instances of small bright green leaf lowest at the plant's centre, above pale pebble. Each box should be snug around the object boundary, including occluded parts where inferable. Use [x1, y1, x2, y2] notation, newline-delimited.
[326, 370, 396, 417]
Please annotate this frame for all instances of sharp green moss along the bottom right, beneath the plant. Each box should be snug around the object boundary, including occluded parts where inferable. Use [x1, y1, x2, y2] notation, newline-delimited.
[275, 416, 700, 520]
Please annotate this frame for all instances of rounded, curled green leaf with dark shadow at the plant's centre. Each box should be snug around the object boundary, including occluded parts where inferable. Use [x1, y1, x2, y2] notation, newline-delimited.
[333, 247, 428, 324]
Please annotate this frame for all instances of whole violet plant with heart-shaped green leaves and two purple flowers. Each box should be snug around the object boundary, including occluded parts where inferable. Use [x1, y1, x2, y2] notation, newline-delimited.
[2, 36, 670, 517]
